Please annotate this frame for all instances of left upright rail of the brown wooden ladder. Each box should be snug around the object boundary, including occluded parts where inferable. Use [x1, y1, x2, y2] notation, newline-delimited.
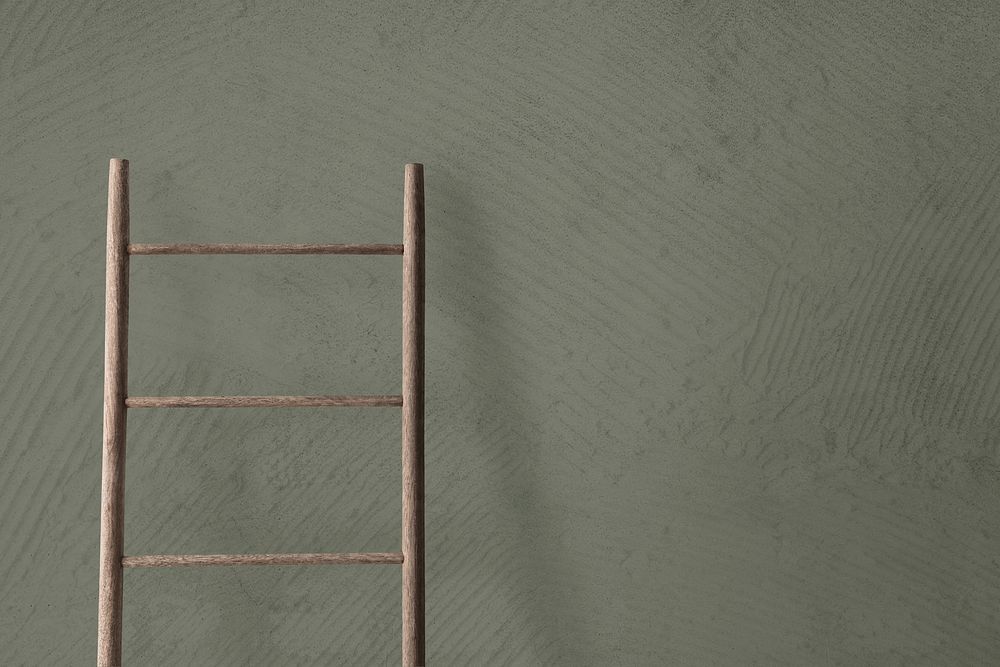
[97, 159, 129, 667]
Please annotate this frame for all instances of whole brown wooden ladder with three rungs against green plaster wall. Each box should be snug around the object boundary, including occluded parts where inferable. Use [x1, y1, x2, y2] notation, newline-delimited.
[97, 159, 425, 667]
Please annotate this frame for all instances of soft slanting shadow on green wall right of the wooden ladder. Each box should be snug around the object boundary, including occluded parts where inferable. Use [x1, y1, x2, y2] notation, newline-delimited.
[427, 169, 590, 665]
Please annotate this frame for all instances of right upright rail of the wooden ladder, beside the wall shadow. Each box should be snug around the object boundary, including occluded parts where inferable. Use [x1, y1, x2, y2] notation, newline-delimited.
[402, 164, 425, 667]
